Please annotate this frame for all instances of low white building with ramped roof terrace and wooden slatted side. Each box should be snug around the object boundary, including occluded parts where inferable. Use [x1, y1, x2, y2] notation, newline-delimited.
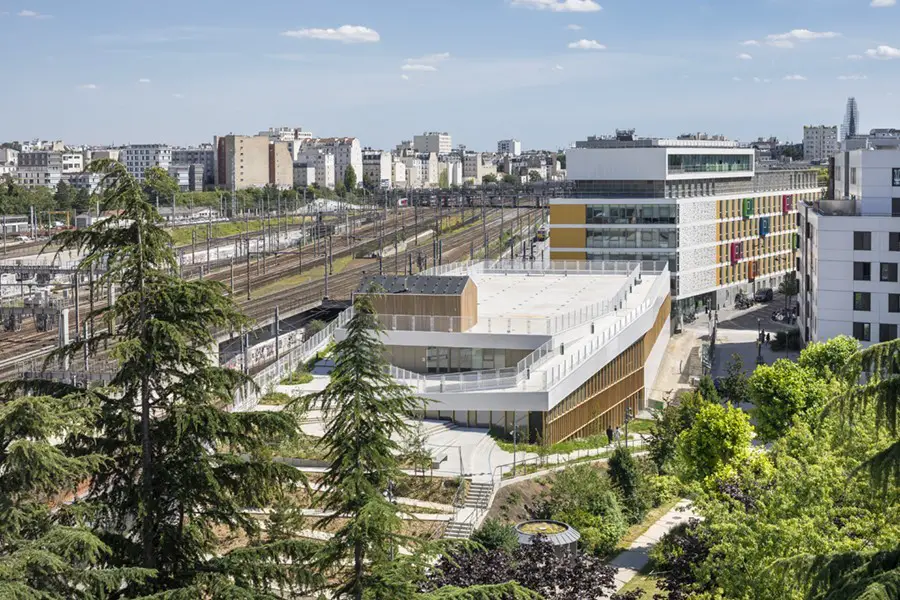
[336, 261, 670, 443]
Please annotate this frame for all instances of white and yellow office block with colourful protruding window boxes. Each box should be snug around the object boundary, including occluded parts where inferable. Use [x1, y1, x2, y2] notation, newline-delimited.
[550, 131, 822, 315]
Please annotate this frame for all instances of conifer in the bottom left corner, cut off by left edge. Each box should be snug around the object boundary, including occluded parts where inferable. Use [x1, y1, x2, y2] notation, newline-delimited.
[0, 389, 152, 600]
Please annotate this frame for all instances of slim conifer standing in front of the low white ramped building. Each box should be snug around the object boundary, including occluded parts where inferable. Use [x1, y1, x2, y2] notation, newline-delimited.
[310, 294, 423, 600]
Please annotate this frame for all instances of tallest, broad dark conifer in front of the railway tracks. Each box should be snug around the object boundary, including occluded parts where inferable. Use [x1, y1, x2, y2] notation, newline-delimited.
[44, 160, 324, 598]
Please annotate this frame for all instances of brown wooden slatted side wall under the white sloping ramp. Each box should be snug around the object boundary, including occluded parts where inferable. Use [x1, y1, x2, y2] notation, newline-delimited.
[543, 297, 671, 444]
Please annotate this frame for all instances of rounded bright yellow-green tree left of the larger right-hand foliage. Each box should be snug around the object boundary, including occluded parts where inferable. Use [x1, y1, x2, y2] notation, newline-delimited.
[749, 359, 830, 441]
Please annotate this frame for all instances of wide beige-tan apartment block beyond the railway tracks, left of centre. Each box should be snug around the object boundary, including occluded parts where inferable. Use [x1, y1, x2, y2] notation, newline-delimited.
[215, 134, 270, 190]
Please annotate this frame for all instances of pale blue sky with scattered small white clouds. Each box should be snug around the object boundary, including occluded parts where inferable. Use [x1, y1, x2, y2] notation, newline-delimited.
[0, 0, 900, 150]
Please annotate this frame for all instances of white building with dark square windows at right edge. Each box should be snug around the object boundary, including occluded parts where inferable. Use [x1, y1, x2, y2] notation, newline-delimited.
[799, 147, 900, 345]
